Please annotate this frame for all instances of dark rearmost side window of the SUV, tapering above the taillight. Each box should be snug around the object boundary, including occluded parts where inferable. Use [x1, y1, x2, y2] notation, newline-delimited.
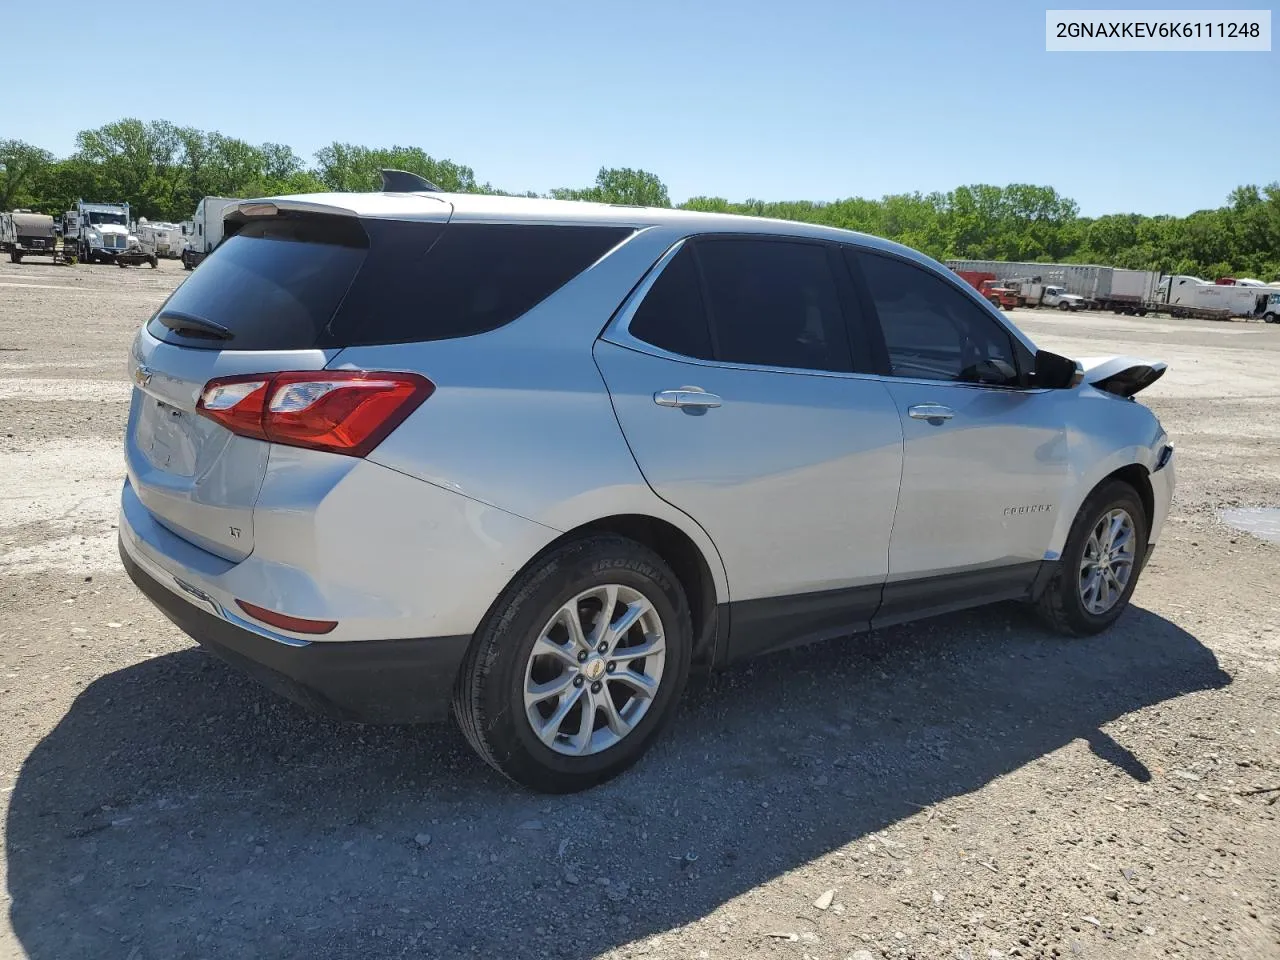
[323, 220, 632, 347]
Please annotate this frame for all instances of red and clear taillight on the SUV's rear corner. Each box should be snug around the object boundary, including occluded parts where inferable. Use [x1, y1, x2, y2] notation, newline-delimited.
[196, 370, 435, 457]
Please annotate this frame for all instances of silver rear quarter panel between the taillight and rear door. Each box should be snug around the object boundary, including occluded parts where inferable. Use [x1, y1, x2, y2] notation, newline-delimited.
[330, 228, 728, 602]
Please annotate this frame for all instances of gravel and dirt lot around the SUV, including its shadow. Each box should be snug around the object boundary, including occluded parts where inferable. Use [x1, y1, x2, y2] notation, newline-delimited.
[0, 261, 1280, 960]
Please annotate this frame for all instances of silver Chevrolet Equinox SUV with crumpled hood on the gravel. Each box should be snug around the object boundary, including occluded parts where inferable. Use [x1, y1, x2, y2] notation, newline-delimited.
[120, 184, 1174, 791]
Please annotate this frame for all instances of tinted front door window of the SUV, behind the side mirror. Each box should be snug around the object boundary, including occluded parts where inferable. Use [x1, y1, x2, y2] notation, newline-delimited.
[849, 251, 1018, 384]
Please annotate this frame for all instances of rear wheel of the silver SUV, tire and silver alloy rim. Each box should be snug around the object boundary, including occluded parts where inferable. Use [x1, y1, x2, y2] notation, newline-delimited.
[453, 535, 692, 794]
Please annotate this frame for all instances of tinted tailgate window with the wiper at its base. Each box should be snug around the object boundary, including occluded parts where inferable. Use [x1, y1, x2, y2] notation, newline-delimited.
[147, 216, 367, 349]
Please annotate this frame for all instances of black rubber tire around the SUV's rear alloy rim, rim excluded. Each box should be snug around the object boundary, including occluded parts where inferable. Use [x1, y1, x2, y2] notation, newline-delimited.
[477, 538, 692, 792]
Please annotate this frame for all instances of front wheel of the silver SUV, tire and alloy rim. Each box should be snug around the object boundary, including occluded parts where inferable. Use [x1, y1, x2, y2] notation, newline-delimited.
[1037, 480, 1149, 636]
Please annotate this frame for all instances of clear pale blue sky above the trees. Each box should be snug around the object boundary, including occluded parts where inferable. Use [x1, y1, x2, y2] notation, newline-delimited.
[0, 0, 1280, 215]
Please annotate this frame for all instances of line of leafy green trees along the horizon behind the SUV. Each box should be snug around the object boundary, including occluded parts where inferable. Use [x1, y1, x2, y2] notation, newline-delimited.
[0, 119, 1280, 282]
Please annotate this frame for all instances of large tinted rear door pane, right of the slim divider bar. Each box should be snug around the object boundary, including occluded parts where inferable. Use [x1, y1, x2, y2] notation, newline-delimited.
[698, 239, 851, 371]
